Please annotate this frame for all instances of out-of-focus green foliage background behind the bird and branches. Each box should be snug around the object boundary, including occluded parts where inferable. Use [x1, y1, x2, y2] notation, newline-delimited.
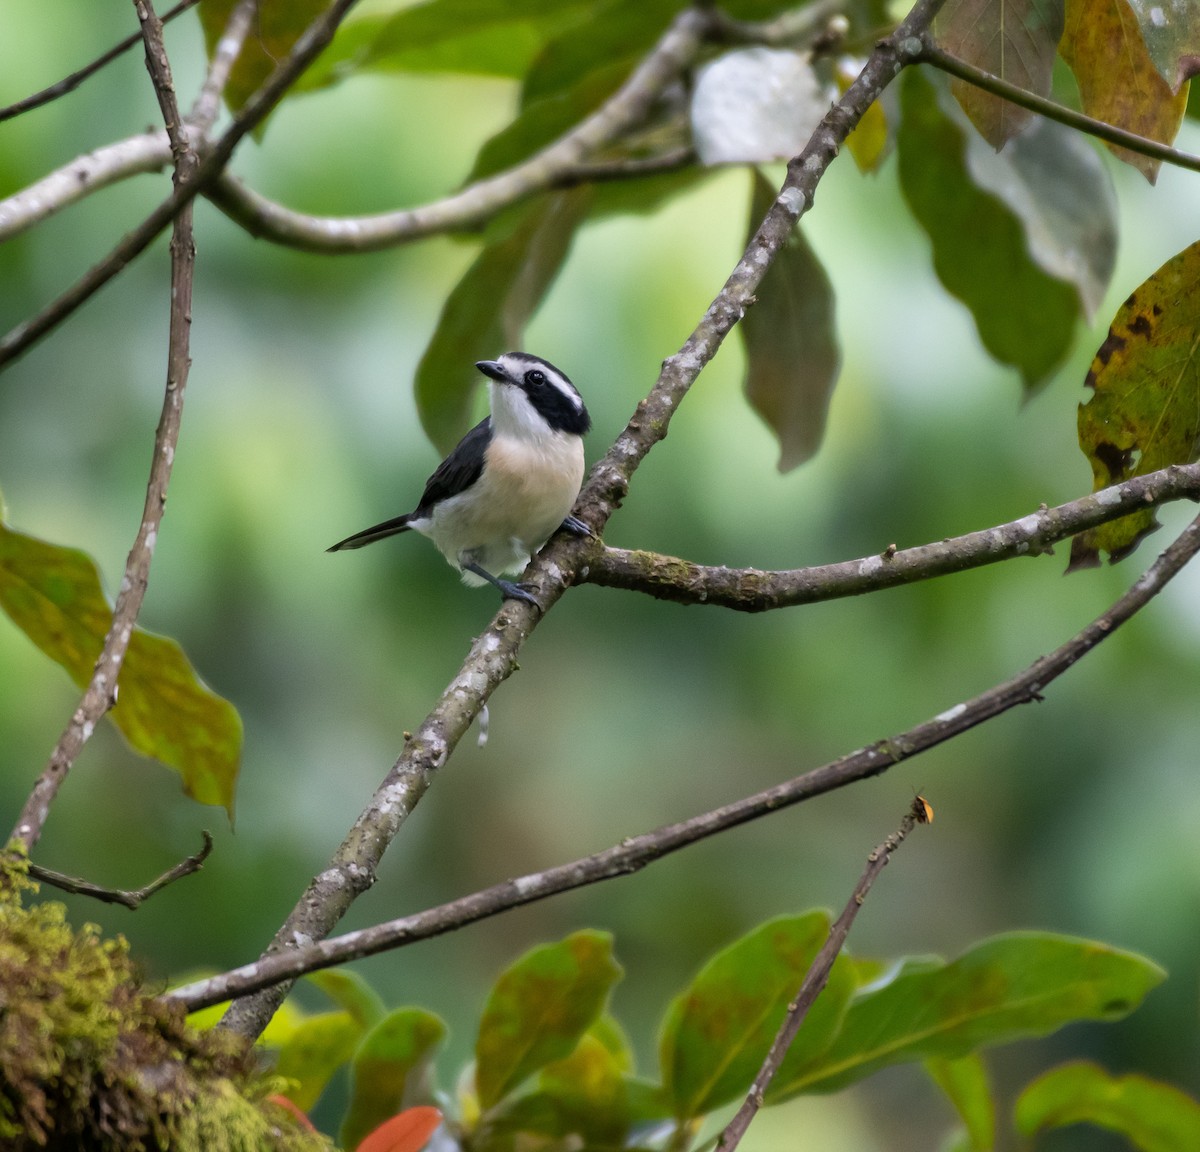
[0, 0, 1200, 1152]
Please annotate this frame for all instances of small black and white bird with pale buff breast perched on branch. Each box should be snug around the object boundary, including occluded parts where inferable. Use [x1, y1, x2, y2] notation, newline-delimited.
[329, 352, 592, 604]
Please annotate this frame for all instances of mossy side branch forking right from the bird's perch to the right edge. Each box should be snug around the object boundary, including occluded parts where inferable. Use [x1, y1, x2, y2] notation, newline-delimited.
[580, 464, 1200, 612]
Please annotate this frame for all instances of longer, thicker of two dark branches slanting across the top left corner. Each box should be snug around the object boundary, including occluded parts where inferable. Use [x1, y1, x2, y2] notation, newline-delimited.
[0, 0, 358, 368]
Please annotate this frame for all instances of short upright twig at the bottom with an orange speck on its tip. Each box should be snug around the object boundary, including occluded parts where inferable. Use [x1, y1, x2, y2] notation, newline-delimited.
[716, 796, 931, 1152]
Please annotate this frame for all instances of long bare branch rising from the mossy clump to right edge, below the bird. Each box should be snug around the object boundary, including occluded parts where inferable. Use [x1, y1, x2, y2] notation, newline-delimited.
[167, 508, 1200, 1012]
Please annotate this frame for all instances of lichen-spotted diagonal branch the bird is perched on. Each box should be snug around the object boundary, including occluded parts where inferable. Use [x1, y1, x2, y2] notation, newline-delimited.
[218, 0, 942, 1036]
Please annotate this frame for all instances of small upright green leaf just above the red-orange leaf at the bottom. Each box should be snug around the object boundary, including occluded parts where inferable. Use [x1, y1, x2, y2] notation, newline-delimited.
[338, 1008, 446, 1148]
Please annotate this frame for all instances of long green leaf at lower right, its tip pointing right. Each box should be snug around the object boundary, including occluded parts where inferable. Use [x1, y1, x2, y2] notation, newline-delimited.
[776, 932, 1166, 1096]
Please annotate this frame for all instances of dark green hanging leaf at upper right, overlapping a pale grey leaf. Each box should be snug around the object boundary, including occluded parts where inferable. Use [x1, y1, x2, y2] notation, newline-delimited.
[898, 68, 1080, 389]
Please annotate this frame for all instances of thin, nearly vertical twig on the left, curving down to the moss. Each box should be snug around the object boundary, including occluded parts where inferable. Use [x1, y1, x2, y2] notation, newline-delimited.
[12, 0, 199, 851]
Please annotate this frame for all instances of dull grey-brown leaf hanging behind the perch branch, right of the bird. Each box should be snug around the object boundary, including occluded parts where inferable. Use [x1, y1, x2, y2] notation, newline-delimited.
[738, 169, 841, 472]
